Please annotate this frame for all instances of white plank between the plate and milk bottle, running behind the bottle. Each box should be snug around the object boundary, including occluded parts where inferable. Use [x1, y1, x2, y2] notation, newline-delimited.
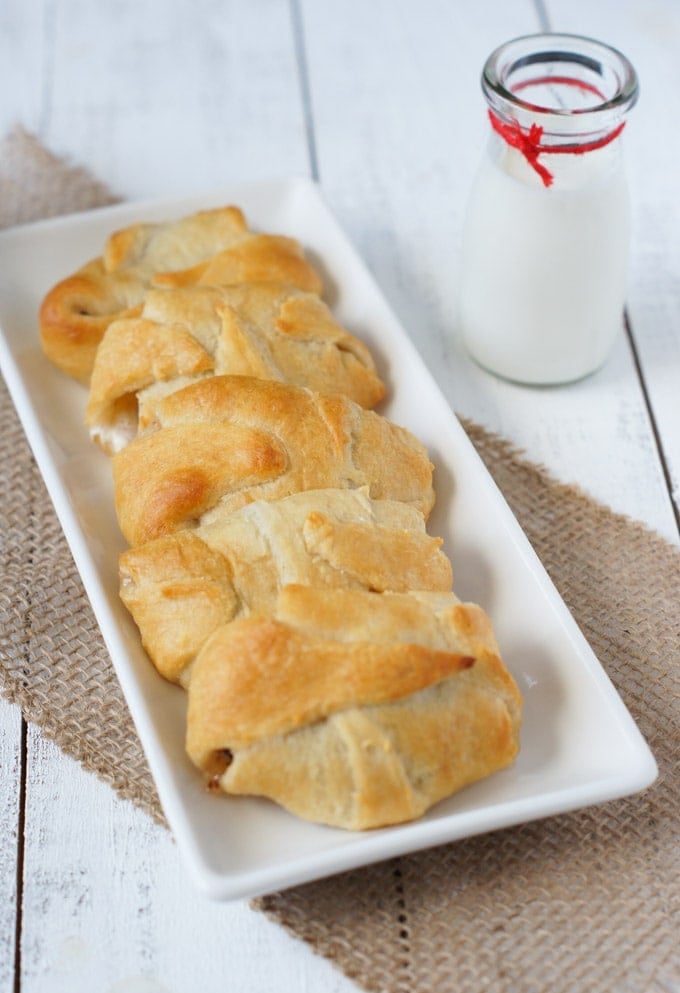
[303, 0, 676, 538]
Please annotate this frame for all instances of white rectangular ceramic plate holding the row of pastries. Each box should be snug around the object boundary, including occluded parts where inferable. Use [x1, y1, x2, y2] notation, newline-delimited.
[0, 180, 656, 899]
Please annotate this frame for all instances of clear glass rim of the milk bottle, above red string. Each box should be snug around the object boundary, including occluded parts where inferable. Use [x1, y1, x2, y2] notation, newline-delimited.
[481, 32, 639, 130]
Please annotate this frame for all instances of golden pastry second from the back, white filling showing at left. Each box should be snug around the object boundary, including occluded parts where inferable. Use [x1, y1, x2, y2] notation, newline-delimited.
[86, 282, 385, 453]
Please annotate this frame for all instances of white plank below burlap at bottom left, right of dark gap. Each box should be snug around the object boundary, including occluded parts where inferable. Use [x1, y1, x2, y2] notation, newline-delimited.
[22, 728, 355, 993]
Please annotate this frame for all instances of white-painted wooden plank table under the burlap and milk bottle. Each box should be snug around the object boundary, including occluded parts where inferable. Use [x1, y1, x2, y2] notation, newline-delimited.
[0, 0, 680, 993]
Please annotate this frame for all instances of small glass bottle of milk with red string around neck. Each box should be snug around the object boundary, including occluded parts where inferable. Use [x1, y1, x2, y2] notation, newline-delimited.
[460, 34, 638, 384]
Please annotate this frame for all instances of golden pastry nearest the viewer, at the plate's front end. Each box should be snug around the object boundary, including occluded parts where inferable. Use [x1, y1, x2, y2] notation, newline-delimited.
[187, 586, 520, 830]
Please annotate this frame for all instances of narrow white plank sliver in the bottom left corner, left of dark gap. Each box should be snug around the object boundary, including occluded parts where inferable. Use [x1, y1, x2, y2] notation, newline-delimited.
[0, 698, 22, 993]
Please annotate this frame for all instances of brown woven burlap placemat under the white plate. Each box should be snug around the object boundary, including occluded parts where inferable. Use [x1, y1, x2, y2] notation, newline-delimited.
[0, 131, 680, 993]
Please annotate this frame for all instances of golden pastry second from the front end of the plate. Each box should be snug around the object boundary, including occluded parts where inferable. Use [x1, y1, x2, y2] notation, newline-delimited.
[120, 488, 452, 685]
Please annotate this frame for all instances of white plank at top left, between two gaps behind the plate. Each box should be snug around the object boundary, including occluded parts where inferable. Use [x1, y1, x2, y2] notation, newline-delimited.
[43, 0, 308, 198]
